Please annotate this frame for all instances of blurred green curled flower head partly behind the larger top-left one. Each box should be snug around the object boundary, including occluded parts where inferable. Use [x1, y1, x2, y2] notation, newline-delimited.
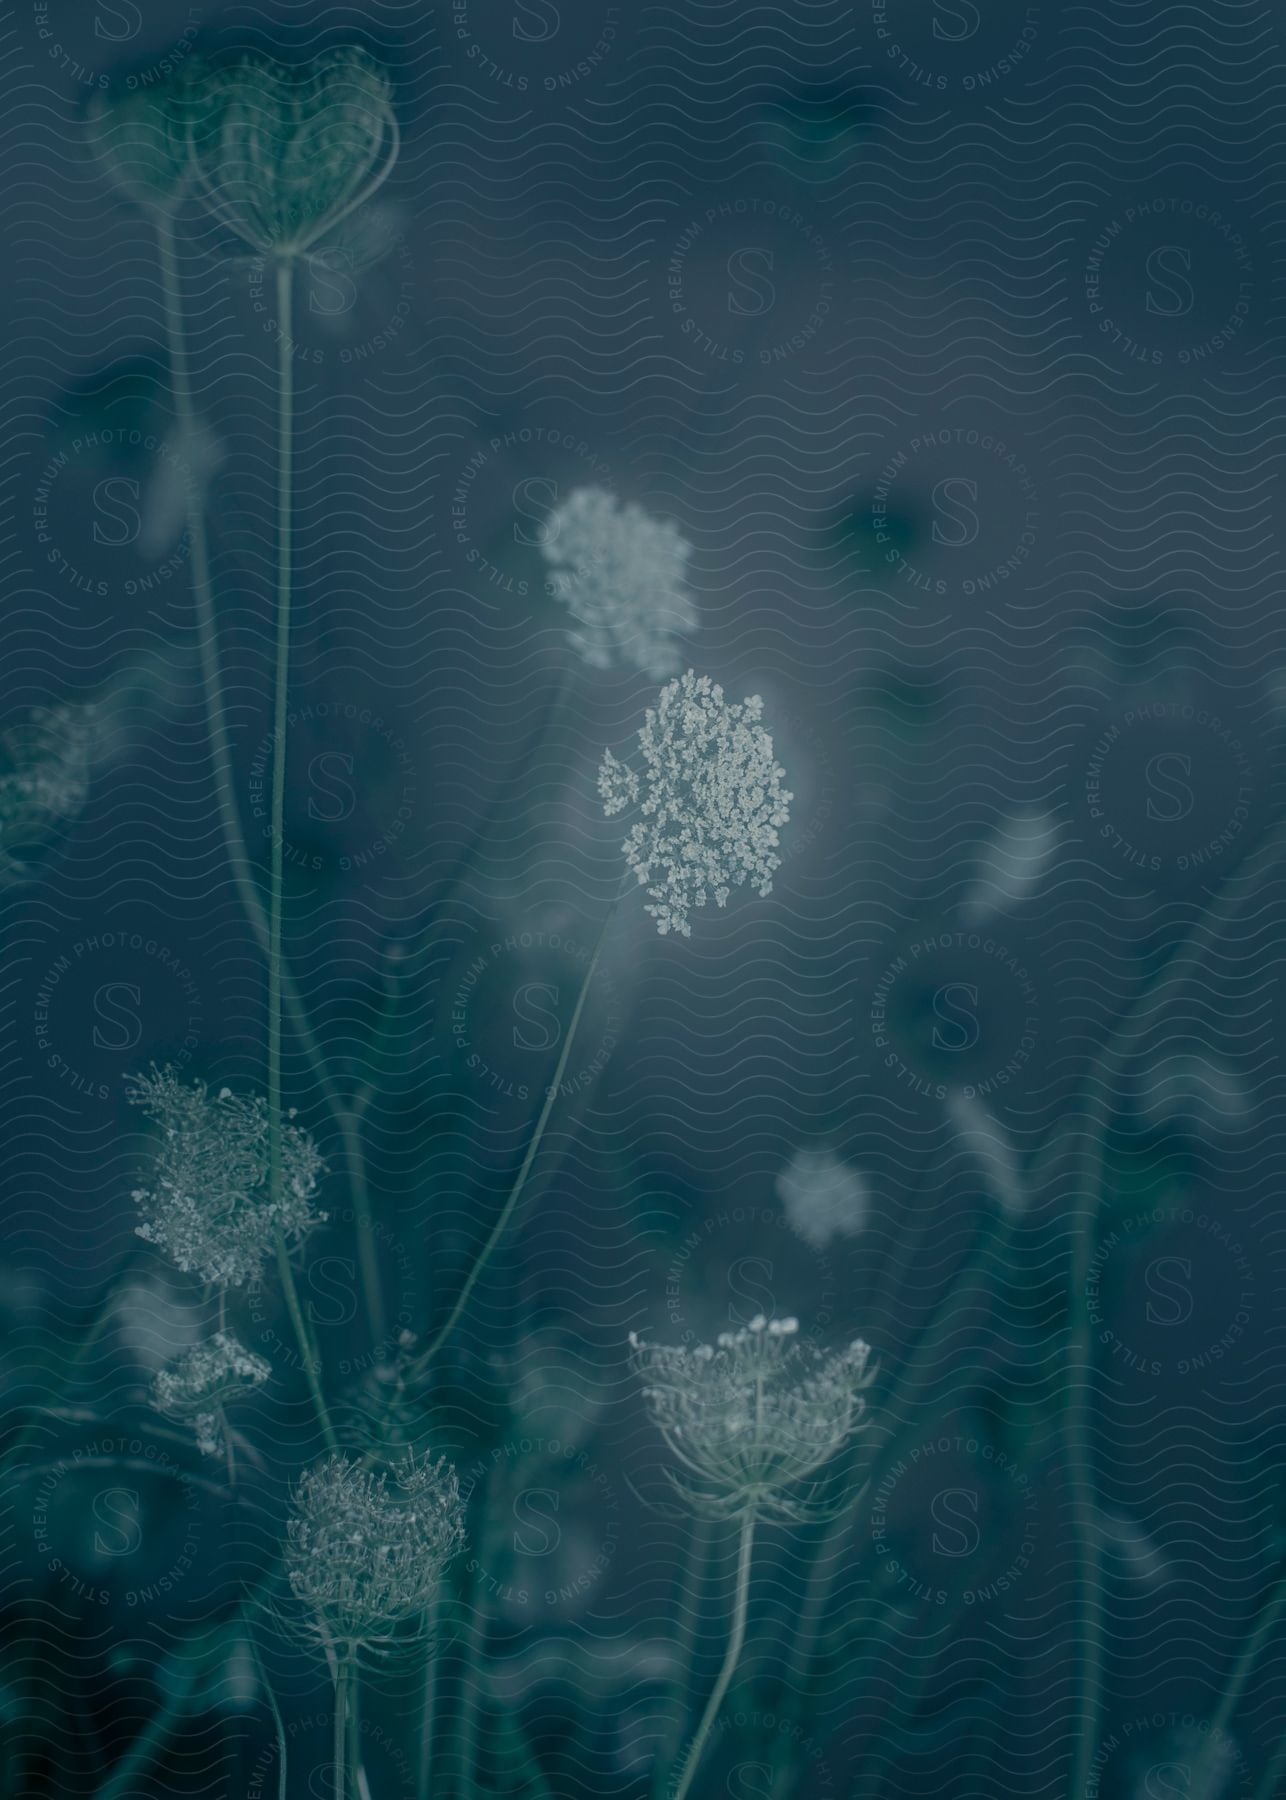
[85, 58, 205, 212]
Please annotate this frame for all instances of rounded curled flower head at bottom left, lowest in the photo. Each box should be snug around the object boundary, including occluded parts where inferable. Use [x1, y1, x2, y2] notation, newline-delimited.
[286, 1456, 465, 1651]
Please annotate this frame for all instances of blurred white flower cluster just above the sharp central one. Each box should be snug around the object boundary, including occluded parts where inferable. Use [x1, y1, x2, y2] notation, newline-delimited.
[542, 488, 697, 680]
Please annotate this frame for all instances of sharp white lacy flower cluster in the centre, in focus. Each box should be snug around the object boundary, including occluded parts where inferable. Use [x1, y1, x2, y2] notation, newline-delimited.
[598, 670, 794, 938]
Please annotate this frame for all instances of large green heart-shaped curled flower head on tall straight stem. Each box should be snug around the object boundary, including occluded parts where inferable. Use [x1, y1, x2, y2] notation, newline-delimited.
[191, 47, 398, 257]
